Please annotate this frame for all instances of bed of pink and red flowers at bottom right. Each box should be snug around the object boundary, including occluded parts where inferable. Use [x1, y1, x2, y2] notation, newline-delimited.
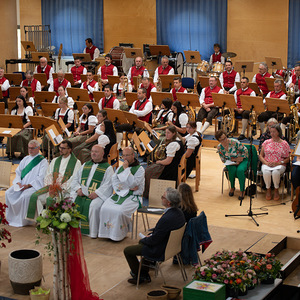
[194, 250, 282, 292]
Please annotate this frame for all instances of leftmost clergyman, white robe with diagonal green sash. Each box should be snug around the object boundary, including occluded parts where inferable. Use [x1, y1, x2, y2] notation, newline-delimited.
[5, 140, 48, 227]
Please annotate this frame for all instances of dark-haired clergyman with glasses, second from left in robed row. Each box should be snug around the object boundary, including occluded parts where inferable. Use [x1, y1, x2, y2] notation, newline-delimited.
[27, 140, 81, 219]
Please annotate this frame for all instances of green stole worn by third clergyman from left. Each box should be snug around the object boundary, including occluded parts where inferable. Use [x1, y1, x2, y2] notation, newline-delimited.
[75, 161, 110, 234]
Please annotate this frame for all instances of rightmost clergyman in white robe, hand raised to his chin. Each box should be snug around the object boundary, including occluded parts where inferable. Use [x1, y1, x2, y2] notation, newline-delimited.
[98, 147, 145, 241]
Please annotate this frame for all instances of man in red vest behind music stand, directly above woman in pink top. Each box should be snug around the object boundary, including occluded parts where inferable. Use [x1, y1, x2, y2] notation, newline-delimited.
[257, 79, 286, 133]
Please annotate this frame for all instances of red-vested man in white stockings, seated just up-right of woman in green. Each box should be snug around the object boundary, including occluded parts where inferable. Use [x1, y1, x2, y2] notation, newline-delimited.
[234, 77, 256, 141]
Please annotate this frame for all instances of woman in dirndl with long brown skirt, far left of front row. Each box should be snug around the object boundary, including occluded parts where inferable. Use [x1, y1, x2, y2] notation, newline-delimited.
[6, 95, 33, 159]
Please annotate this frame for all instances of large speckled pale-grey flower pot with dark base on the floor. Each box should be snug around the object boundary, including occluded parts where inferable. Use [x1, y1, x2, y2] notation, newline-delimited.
[8, 249, 43, 295]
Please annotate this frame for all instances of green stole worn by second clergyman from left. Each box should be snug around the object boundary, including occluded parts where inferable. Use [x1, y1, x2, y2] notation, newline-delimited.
[27, 153, 77, 219]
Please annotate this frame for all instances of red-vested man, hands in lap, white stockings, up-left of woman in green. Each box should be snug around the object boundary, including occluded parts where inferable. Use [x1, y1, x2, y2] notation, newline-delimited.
[197, 76, 223, 134]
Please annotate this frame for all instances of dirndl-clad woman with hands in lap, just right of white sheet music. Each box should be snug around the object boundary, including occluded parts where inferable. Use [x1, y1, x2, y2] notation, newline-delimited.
[69, 103, 97, 149]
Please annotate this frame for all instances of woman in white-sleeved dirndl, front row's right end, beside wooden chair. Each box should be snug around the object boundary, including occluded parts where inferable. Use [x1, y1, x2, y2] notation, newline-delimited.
[184, 121, 202, 177]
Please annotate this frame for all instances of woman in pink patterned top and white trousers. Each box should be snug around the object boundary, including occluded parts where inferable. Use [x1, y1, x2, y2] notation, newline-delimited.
[259, 124, 290, 200]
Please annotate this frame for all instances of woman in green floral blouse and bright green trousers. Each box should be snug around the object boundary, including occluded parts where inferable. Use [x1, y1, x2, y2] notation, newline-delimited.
[215, 130, 248, 200]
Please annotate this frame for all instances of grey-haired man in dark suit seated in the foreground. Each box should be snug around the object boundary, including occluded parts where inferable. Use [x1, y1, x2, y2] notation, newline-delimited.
[124, 188, 185, 284]
